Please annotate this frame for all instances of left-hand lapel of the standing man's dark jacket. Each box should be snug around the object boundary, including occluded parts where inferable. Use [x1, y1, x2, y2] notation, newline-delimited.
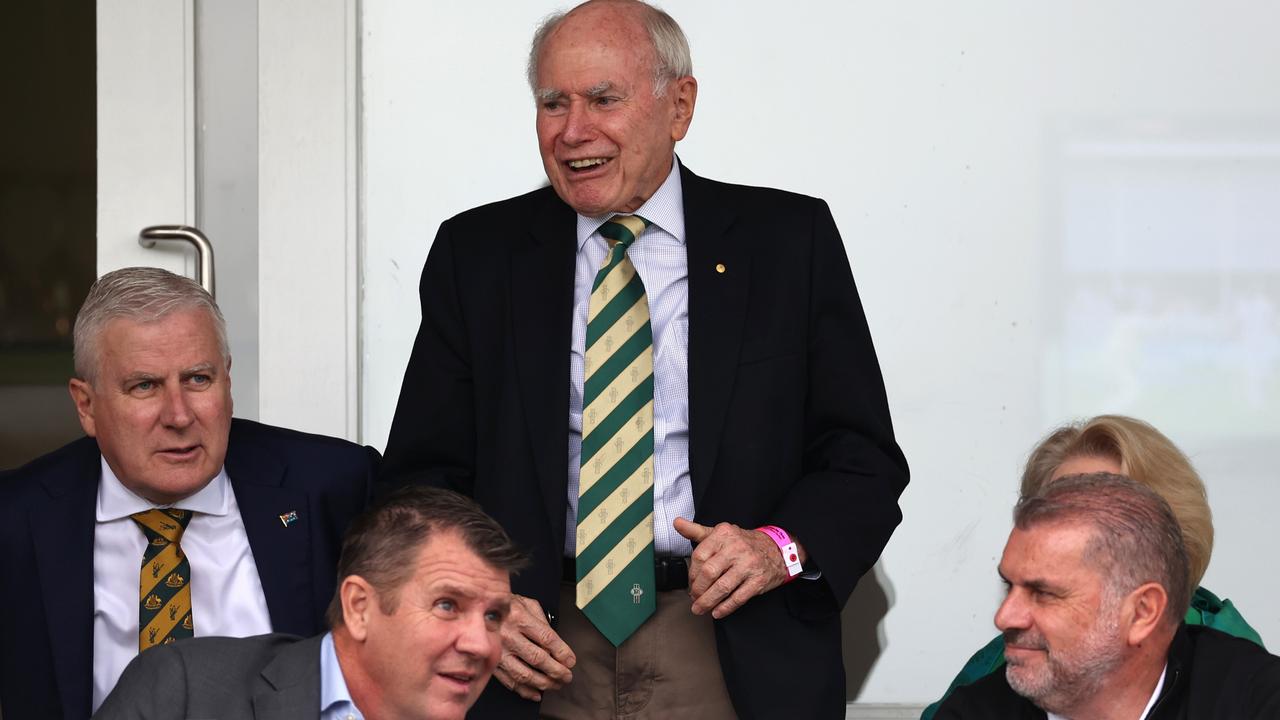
[511, 191, 577, 547]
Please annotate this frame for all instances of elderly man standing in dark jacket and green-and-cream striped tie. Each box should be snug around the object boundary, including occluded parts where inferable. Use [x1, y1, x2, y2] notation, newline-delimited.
[385, 0, 908, 719]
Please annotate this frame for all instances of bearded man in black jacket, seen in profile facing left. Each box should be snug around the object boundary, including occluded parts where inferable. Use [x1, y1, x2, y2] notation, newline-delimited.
[937, 473, 1280, 720]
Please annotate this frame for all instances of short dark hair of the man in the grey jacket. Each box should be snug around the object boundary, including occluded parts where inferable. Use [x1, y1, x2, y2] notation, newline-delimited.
[325, 486, 527, 628]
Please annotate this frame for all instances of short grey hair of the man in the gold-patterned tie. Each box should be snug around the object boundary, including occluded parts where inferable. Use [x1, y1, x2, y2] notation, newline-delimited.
[72, 268, 230, 384]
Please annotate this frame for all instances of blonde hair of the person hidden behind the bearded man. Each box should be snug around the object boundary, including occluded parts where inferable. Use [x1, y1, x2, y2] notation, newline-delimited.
[1021, 415, 1213, 587]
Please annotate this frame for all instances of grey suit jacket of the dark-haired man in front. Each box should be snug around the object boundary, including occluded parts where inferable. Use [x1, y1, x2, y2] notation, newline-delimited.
[93, 633, 324, 720]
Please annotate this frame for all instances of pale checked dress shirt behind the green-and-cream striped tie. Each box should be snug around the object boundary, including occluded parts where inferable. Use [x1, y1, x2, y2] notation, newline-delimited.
[564, 159, 694, 557]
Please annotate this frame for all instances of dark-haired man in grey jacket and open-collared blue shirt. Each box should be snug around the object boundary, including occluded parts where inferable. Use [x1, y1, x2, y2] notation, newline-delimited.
[95, 487, 525, 720]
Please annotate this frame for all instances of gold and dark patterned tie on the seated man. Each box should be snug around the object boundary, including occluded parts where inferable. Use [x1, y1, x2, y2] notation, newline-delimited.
[129, 509, 195, 652]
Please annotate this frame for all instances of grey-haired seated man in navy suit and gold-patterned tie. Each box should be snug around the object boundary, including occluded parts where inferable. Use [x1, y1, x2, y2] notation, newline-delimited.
[0, 268, 376, 719]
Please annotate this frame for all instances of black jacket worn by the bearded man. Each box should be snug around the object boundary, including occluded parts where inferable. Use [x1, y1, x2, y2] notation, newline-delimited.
[934, 625, 1280, 720]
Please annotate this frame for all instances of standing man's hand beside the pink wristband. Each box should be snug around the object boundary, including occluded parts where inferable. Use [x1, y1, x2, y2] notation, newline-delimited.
[675, 518, 804, 620]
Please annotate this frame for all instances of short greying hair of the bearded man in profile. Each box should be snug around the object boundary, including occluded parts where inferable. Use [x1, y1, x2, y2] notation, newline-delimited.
[1014, 473, 1192, 626]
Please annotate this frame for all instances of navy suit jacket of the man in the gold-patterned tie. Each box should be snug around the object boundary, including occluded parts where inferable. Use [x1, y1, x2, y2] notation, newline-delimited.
[0, 420, 378, 720]
